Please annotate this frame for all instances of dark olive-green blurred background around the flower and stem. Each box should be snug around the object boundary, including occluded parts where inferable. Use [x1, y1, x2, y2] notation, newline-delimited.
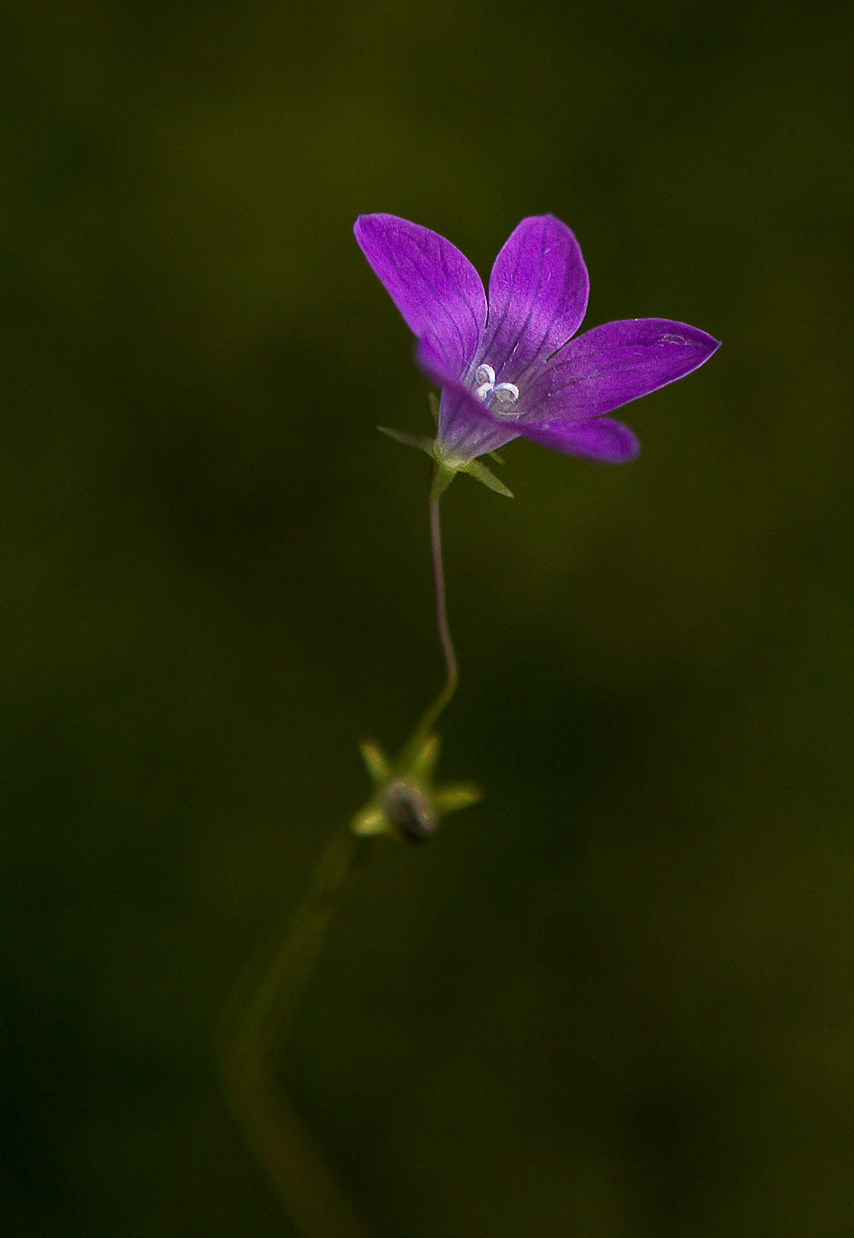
[0, 0, 854, 1238]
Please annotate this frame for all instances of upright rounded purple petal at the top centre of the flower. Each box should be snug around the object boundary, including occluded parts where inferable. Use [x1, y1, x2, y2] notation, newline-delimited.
[483, 215, 590, 383]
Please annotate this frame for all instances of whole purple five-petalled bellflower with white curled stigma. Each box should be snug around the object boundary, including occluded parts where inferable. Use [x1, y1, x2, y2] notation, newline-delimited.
[354, 214, 718, 480]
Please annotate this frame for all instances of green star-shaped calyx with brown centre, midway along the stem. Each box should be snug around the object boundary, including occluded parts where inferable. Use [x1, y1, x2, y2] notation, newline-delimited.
[350, 735, 481, 843]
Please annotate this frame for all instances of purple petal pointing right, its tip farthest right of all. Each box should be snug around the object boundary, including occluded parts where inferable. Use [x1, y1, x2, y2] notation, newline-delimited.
[525, 318, 720, 422]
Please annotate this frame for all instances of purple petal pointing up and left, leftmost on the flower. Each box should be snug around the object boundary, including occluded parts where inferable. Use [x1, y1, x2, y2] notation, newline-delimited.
[353, 214, 486, 378]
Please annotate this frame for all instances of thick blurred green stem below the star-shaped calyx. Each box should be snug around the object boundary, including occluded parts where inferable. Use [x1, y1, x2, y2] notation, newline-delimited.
[220, 829, 368, 1238]
